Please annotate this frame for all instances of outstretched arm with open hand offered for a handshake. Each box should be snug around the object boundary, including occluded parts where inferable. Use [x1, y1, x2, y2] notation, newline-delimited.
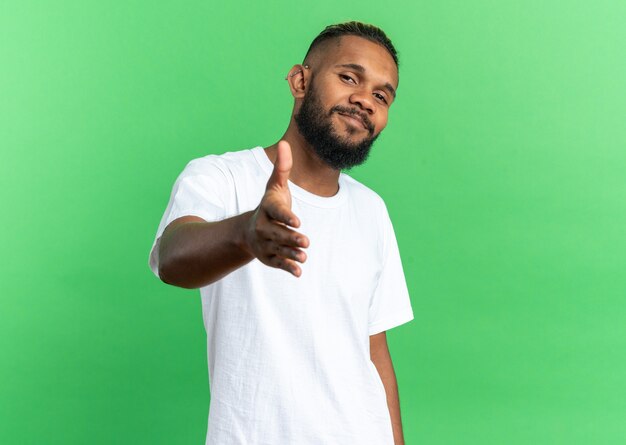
[158, 140, 309, 289]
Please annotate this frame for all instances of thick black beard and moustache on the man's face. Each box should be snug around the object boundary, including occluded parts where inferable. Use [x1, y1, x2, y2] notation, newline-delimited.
[294, 82, 380, 170]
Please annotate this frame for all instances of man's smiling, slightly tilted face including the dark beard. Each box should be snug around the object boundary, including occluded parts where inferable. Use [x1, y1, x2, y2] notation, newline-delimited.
[294, 36, 398, 170]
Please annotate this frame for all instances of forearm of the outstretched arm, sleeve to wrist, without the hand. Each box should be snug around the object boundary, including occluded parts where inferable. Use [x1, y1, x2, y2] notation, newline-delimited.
[159, 211, 254, 289]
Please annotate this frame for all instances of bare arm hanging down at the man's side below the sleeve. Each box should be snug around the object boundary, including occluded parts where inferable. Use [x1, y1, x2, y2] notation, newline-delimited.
[370, 331, 404, 445]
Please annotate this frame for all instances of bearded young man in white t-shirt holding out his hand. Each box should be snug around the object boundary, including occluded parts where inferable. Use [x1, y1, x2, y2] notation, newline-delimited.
[150, 22, 413, 445]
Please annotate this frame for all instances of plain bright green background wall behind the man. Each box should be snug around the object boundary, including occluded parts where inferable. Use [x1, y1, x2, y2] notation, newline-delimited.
[0, 0, 626, 445]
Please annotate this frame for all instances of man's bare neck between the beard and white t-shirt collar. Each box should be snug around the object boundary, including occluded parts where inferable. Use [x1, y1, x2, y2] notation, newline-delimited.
[265, 116, 341, 197]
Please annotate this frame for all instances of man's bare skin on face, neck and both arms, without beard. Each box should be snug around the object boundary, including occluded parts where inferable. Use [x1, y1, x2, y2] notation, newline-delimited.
[158, 36, 404, 445]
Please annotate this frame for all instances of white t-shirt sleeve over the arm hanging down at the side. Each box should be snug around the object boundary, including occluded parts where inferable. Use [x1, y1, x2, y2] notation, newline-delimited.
[369, 203, 413, 335]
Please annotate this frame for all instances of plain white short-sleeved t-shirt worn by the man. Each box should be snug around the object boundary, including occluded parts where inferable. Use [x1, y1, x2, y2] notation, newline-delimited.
[149, 147, 413, 445]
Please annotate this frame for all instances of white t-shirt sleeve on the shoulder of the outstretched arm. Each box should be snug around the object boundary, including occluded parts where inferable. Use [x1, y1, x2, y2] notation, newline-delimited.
[148, 155, 232, 277]
